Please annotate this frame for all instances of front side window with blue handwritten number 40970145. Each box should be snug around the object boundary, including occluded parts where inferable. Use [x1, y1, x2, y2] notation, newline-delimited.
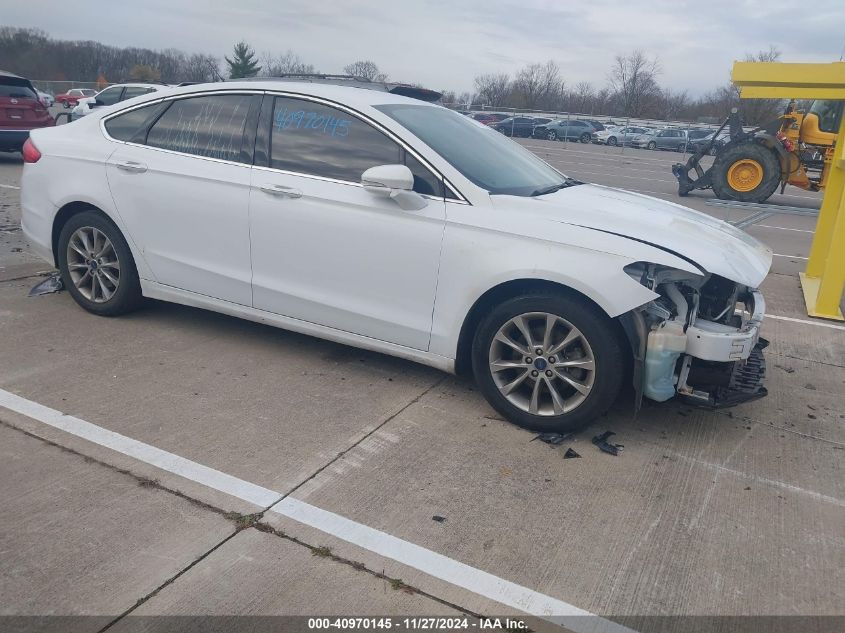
[270, 97, 402, 183]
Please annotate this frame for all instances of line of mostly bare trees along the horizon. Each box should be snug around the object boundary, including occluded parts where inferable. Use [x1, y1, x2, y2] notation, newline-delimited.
[0, 27, 783, 125]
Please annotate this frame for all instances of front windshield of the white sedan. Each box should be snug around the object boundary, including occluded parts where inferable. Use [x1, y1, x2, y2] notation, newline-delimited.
[376, 104, 569, 196]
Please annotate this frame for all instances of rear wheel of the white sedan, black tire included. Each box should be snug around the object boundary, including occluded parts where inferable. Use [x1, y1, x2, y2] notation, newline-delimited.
[57, 209, 143, 316]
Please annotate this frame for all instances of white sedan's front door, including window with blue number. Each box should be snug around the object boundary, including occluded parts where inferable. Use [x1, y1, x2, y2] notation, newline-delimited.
[250, 95, 445, 350]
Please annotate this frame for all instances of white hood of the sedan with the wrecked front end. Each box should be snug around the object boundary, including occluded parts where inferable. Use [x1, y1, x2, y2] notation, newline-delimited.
[521, 184, 772, 288]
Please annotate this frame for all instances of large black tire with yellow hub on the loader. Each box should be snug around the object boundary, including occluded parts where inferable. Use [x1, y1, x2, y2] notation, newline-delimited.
[712, 142, 781, 202]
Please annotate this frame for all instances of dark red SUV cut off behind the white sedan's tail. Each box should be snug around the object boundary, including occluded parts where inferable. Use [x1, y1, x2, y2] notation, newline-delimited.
[0, 70, 56, 152]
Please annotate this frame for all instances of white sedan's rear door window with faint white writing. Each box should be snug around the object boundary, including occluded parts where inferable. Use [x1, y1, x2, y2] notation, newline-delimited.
[147, 95, 251, 161]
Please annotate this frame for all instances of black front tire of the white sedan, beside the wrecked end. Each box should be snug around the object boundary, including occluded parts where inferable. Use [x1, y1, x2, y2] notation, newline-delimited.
[472, 292, 627, 431]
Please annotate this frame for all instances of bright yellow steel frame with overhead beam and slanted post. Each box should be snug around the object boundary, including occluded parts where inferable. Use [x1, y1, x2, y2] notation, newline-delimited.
[731, 62, 845, 321]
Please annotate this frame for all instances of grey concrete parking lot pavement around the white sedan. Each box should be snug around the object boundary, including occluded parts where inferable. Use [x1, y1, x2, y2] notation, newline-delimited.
[0, 141, 845, 630]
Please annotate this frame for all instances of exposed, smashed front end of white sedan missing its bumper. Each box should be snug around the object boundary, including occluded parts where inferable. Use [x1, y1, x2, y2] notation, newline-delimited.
[620, 262, 768, 409]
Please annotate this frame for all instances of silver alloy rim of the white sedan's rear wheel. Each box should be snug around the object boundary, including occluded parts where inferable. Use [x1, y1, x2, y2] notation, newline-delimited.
[67, 226, 120, 303]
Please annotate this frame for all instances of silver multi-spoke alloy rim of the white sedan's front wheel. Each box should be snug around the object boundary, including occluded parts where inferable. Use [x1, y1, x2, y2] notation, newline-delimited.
[489, 312, 595, 416]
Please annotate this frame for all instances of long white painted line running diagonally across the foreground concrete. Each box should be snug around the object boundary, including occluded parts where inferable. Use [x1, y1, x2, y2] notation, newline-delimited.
[0, 389, 636, 633]
